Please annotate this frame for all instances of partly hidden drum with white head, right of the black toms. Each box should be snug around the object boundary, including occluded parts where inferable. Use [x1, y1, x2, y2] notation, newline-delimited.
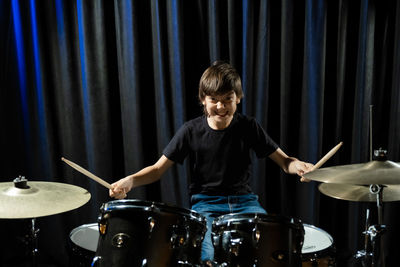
[301, 224, 336, 267]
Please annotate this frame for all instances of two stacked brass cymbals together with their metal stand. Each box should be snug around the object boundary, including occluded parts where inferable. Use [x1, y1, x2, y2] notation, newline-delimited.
[304, 149, 400, 267]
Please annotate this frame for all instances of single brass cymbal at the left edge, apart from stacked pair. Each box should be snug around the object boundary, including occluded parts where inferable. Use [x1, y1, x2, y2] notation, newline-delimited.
[0, 182, 90, 219]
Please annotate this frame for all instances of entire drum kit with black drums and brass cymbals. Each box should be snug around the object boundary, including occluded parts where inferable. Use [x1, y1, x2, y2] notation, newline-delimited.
[0, 150, 400, 267]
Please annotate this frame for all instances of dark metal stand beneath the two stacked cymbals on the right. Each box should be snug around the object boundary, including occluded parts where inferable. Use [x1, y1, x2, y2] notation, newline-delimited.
[355, 185, 386, 267]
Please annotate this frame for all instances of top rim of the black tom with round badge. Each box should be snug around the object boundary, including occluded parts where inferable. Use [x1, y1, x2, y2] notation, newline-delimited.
[100, 199, 206, 223]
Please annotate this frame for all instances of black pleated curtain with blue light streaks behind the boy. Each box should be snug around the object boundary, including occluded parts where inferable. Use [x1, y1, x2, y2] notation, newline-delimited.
[0, 0, 400, 266]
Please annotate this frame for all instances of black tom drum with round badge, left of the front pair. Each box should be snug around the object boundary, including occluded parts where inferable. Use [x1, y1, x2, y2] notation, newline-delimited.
[93, 199, 206, 267]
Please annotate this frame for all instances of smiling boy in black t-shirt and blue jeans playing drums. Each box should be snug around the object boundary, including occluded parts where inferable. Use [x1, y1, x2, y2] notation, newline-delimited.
[110, 61, 313, 265]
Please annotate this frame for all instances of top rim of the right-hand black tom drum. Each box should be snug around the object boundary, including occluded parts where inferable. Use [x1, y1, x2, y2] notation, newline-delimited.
[213, 213, 303, 228]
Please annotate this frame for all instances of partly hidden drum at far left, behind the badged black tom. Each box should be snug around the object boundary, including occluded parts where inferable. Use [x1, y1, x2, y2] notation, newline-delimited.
[68, 223, 99, 267]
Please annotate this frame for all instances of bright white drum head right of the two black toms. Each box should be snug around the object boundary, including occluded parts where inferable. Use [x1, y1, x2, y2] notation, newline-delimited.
[301, 224, 333, 254]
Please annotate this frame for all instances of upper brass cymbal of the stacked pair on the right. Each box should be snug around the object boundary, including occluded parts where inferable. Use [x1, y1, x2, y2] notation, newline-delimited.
[303, 160, 400, 185]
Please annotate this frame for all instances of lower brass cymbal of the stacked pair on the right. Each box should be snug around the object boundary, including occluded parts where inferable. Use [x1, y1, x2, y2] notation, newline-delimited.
[318, 183, 400, 202]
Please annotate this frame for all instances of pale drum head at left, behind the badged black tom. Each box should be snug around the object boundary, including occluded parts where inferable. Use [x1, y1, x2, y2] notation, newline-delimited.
[69, 223, 99, 252]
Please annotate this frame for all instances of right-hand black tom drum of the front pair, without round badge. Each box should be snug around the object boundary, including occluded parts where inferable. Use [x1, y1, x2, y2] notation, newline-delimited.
[212, 213, 304, 267]
